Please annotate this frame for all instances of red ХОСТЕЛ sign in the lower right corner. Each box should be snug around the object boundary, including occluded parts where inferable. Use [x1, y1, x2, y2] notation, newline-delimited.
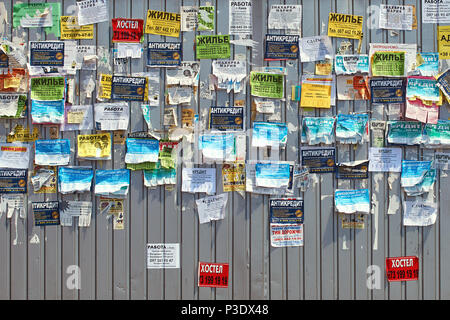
[386, 256, 419, 282]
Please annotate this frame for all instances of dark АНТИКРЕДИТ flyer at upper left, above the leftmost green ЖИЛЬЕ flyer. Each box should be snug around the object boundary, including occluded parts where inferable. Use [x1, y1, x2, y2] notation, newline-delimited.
[30, 41, 64, 67]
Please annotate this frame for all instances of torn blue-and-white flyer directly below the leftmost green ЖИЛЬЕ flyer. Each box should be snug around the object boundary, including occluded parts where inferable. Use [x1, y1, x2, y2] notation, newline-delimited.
[31, 100, 64, 124]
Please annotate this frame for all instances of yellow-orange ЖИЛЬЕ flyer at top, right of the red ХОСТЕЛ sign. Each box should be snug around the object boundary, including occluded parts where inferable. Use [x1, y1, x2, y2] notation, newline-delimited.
[145, 10, 181, 38]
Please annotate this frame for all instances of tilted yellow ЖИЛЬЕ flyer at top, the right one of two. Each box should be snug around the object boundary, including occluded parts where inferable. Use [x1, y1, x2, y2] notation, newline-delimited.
[328, 12, 363, 39]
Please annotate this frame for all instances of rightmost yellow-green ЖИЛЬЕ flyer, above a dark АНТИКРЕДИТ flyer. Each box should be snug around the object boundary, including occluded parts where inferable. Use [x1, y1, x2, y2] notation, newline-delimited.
[372, 51, 405, 77]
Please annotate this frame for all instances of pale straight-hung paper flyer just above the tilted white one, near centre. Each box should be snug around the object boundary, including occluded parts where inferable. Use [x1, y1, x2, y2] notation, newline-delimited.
[181, 168, 216, 194]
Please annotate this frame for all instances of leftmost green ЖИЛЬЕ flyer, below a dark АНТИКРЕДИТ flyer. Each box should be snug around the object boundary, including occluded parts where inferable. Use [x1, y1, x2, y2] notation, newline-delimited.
[31, 77, 65, 101]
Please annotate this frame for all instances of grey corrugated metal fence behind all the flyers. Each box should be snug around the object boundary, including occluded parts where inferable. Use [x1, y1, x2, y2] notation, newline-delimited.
[0, 0, 450, 300]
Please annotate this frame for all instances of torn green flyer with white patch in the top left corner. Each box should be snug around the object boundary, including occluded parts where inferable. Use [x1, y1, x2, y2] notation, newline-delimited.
[13, 2, 61, 37]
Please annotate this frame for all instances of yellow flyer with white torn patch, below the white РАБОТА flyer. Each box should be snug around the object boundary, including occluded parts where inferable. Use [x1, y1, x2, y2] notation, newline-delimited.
[77, 133, 112, 160]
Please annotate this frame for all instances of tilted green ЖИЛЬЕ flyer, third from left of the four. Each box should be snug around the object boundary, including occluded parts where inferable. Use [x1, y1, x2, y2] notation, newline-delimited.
[250, 71, 284, 99]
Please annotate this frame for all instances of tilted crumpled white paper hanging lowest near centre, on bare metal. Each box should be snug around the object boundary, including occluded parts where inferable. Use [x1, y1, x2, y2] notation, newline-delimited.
[195, 193, 228, 223]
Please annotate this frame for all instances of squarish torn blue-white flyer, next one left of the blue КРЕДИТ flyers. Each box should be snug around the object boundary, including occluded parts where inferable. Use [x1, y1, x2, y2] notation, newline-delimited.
[336, 113, 369, 144]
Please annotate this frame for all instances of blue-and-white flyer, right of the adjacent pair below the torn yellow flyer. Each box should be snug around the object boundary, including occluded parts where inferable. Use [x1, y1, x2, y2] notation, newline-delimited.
[95, 169, 130, 197]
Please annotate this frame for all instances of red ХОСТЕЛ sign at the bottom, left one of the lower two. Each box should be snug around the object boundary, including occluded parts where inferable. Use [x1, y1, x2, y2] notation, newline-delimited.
[198, 262, 228, 288]
